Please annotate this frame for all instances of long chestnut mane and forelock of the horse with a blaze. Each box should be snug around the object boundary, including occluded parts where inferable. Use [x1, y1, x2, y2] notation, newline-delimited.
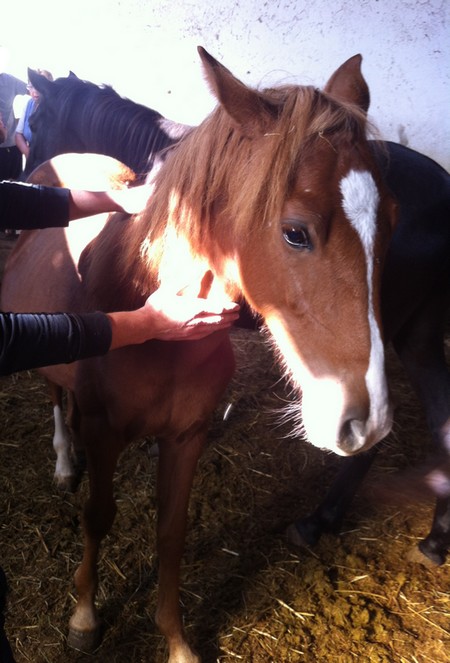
[122, 86, 367, 288]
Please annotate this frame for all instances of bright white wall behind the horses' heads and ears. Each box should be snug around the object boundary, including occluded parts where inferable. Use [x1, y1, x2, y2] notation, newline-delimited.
[0, 0, 450, 169]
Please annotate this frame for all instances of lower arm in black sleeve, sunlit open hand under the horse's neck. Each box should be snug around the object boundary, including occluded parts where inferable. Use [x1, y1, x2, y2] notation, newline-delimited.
[0, 290, 239, 375]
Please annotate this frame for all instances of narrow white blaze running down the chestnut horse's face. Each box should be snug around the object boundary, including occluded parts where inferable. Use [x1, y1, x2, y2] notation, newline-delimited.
[340, 170, 391, 435]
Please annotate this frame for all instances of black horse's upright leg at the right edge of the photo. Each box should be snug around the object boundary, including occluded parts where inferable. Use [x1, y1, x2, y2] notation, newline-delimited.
[393, 296, 450, 564]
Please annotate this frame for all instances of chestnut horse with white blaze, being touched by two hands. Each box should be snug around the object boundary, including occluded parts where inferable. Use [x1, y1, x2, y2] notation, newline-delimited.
[2, 49, 396, 663]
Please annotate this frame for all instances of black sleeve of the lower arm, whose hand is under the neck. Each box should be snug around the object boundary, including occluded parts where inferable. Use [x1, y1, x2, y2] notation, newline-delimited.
[0, 312, 112, 375]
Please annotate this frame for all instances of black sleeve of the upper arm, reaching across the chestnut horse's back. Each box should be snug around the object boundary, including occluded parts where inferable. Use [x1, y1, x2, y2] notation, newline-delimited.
[0, 181, 69, 230]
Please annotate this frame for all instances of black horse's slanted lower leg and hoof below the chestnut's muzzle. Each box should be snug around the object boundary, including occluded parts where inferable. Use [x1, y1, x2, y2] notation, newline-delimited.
[286, 447, 378, 546]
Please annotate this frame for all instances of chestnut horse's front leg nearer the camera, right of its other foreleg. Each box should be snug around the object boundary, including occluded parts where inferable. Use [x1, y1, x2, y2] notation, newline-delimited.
[156, 427, 206, 663]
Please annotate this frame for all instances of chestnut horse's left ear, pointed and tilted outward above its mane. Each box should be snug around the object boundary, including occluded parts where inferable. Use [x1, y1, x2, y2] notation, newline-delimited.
[198, 46, 277, 135]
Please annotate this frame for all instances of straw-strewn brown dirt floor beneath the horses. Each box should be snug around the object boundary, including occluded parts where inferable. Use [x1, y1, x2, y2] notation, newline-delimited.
[0, 236, 450, 663]
